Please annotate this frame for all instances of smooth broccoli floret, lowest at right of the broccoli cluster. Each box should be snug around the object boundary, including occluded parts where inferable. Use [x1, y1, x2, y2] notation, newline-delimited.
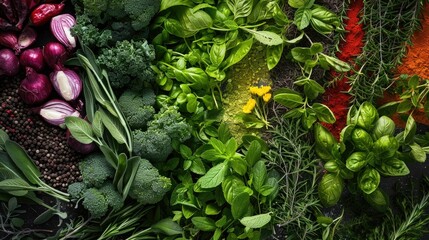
[129, 159, 171, 204]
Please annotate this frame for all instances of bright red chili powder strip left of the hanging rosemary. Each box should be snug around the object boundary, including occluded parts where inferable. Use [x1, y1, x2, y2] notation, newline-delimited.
[323, 0, 365, 139]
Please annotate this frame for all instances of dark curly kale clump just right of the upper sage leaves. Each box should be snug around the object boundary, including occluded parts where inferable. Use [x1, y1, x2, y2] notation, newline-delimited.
[97, 40, 155, 88]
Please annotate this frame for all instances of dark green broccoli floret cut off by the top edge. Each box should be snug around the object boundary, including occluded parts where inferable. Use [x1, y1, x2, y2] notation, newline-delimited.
[123, 0, 161, 31]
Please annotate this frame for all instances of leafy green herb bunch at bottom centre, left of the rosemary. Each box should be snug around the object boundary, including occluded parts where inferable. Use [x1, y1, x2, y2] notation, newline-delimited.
[167, 124, 278, 239]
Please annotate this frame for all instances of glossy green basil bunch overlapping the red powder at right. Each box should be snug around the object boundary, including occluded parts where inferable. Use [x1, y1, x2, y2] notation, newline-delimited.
[314, 102, 426, 211]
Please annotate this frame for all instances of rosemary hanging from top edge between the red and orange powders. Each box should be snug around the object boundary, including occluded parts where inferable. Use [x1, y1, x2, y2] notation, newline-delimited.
[349, 0, 424, 103]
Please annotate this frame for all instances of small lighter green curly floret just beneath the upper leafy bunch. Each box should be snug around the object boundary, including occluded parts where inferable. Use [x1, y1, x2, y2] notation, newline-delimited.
[148, 106, 191, 142]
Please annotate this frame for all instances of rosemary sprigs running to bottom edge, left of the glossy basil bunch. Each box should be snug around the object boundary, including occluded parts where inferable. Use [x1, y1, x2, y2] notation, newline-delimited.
[267, 111, 321, 239]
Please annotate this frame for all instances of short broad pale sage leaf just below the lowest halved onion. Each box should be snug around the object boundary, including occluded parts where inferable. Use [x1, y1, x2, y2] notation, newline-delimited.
[65, 116, 94, 144]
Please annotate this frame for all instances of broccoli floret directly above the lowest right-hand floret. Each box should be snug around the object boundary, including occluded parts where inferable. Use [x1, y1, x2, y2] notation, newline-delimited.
[133, 129, 173, 162]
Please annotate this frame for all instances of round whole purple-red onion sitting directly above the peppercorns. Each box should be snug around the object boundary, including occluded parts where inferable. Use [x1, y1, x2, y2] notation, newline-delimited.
[18, 68, 52, 105]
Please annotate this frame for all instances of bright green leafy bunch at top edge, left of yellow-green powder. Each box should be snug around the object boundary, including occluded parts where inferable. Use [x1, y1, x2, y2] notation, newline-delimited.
[152, 0, 289, 113]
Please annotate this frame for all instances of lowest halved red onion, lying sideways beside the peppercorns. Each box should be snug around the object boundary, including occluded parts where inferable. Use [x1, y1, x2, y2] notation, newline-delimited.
[38, 99, 80, 128]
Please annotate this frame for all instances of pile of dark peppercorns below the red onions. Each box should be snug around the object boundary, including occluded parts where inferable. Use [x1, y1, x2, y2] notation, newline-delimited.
[0, 79, 82, 191]
